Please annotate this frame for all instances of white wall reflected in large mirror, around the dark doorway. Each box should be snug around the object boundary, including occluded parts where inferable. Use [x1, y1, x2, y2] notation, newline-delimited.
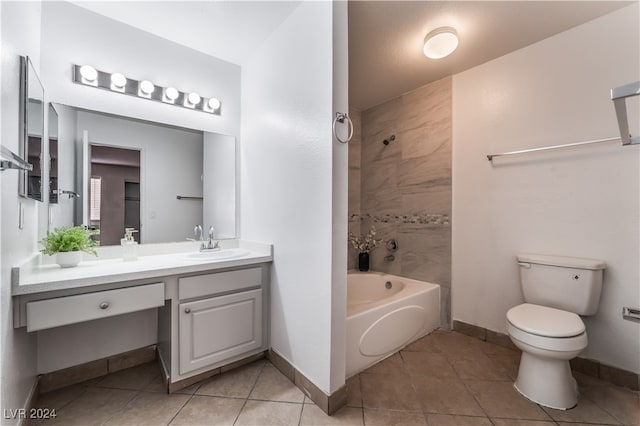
[73, 111, 202, 243]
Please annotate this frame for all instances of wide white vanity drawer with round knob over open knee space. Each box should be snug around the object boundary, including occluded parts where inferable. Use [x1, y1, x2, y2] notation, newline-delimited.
[27, 283, 164, 331]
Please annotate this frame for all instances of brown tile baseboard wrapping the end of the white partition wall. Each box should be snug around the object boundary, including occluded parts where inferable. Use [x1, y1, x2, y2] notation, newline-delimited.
[267, 349, 347, 416]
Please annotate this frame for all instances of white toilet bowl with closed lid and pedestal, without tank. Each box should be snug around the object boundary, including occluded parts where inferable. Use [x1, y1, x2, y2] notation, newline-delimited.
[507, 303, 587, 410]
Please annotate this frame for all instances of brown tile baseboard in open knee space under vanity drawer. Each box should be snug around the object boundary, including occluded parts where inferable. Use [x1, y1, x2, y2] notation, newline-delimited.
[38, 345, 157, 393]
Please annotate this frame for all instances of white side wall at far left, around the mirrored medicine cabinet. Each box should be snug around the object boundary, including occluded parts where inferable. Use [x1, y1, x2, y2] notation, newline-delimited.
[0, 2, 41, 424]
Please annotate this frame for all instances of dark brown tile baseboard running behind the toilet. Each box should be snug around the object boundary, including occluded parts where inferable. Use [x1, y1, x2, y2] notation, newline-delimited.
[453, 320, 640, 391]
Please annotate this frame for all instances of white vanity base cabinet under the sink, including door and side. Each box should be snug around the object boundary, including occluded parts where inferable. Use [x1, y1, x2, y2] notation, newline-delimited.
[158, 264, 269, 389]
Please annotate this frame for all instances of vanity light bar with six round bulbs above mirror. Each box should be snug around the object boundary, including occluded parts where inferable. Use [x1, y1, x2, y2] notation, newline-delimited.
[72, 65, 222, 115]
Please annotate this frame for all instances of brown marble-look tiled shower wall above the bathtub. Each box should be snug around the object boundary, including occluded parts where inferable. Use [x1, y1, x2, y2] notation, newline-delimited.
[349, 77, 452, 327]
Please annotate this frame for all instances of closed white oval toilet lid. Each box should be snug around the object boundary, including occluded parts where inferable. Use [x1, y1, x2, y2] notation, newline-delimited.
[507, 303, 585, 337]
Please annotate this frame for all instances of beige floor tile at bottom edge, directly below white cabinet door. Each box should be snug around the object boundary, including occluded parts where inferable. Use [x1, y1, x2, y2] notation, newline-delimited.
[170, 395, 244, 426]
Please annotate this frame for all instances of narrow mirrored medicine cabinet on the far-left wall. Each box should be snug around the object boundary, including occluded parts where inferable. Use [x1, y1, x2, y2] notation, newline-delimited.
[18, 56, 44, 201]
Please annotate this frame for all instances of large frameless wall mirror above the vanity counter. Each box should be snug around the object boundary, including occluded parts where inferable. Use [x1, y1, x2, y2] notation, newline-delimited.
[49, 104, 236, 245]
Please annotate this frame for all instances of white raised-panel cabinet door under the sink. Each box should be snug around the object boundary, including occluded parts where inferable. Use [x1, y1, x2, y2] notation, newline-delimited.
[180, 289, 262, 374]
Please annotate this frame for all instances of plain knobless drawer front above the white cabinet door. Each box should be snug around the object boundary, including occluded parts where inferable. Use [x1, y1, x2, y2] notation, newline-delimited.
[178, 268, 262, 300]
